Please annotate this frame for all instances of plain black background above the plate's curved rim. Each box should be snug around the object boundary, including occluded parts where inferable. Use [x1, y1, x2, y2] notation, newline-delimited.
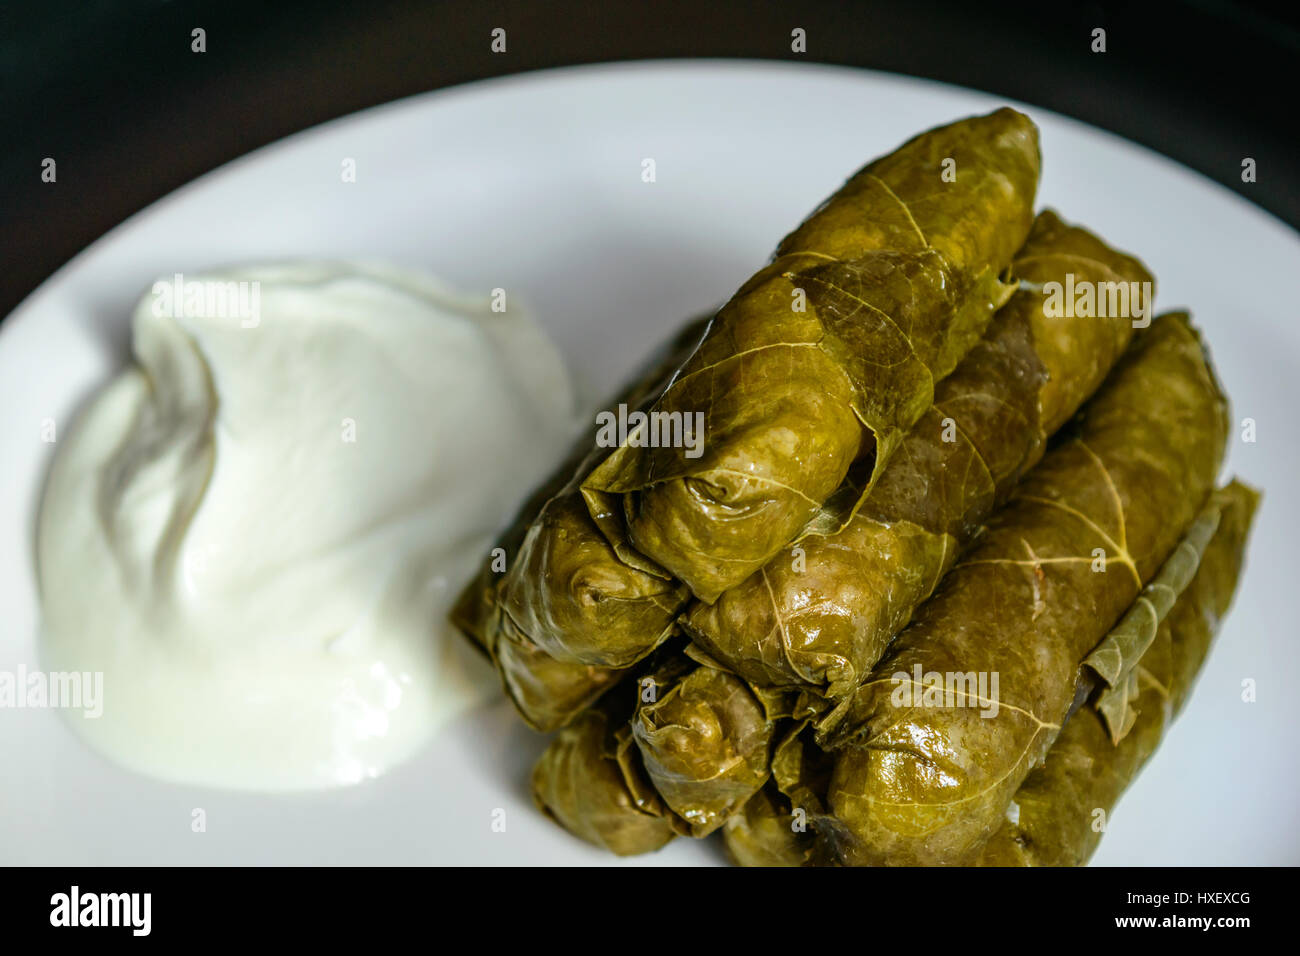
[0, 0, 1300, 321]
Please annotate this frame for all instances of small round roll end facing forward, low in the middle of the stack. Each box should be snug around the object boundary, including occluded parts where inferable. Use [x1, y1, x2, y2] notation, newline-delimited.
[632, 667, 776, 836]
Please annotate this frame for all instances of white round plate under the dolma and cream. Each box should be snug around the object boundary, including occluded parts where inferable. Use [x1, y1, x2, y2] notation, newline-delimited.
[0, 61, 1300, 865]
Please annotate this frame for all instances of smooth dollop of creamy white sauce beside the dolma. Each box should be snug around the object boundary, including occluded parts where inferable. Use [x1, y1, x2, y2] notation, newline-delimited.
[38, 263, 573, 790]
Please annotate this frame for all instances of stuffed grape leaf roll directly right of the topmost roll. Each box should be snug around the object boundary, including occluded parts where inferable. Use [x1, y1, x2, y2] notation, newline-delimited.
[681, 212, 1152, 700]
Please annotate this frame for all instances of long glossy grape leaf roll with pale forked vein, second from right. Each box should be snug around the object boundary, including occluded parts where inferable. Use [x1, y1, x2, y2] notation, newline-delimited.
[823, 315, 1227, 865]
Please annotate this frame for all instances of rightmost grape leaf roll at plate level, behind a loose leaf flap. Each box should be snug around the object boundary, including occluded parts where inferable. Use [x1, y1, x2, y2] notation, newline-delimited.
[978, 481, 1260, 866]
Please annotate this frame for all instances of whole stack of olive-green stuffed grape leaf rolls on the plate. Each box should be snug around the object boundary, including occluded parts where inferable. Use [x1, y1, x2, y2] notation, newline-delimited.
[454, 109, 1257, 865]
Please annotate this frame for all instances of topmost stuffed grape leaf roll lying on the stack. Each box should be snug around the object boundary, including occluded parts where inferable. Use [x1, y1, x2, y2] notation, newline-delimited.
[584, 109, 1039, 602]
